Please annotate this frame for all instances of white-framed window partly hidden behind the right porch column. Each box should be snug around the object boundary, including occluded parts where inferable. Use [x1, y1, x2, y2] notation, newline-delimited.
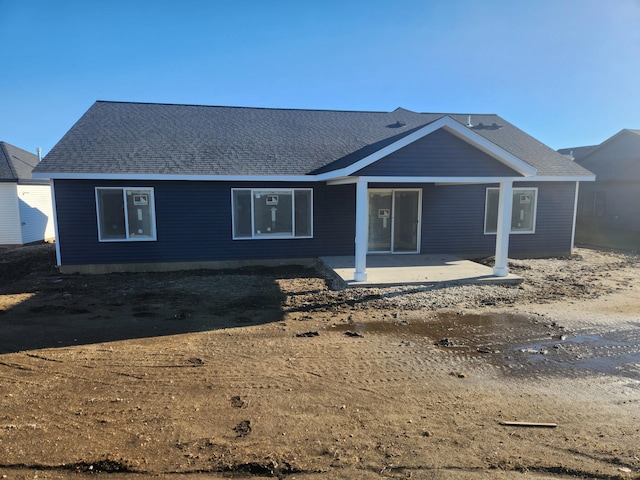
[484, 188, 538, 234]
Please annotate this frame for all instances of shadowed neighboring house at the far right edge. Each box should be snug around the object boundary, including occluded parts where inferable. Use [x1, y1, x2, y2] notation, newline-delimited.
[559, 129, 640, 249]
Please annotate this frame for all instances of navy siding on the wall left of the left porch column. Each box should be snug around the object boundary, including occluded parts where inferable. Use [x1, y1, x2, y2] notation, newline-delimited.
[55, 180, 355, 265]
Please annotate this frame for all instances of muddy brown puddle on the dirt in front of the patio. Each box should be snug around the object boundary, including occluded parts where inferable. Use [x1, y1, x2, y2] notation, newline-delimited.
[332, 313, 640, 378]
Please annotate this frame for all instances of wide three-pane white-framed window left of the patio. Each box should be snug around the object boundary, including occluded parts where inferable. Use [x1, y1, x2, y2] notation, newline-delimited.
[231, 189, 313, 239]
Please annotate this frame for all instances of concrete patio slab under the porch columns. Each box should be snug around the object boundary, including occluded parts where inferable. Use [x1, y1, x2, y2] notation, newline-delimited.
[320, 254, 523, 287]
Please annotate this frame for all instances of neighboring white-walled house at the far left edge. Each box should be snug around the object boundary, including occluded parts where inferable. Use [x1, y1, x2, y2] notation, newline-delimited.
[0, 142, 54, 245]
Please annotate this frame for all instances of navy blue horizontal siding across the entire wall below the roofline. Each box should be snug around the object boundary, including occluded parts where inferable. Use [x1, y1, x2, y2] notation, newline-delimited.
[55, 180, 575, 265]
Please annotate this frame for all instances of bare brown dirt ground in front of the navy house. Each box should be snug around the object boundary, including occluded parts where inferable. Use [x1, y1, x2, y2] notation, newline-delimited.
[0, 245, 640, 480]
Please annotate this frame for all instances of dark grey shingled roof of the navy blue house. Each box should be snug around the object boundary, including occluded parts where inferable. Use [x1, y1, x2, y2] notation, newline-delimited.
[35, 101, 591, 178]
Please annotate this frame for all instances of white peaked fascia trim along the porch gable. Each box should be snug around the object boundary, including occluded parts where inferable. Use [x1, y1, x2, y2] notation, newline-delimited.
[318, 116, 537, 180]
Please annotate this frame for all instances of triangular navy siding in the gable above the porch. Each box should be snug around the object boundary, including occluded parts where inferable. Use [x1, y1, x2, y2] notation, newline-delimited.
[354, 129, 520, 177]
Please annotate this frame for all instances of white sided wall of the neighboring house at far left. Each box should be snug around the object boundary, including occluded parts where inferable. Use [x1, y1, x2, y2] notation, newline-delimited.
[18, 185, 55, 243]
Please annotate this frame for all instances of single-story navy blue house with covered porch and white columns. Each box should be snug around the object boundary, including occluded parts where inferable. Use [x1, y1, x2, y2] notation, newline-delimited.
[34, 101, 593, 281]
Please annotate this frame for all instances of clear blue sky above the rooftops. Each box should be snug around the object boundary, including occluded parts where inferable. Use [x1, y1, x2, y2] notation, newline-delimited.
[0, 0, 640, 153]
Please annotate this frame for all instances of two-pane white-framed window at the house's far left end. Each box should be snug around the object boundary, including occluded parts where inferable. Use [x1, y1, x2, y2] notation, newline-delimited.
[96, 188, 156, 242]
